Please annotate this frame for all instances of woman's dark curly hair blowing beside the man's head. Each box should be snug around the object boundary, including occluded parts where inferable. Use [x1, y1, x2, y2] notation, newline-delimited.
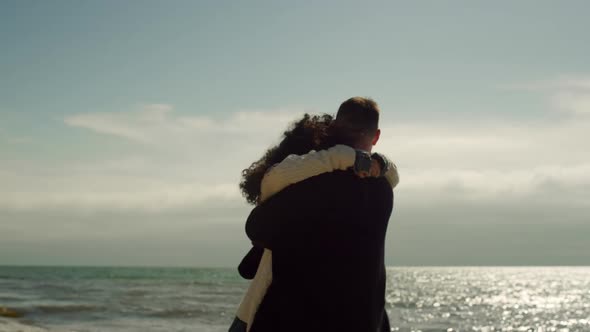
[240, 113, 334, 204]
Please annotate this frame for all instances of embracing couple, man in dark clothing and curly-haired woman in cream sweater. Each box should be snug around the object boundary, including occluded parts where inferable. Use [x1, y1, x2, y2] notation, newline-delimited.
[229, 97, 399, 332]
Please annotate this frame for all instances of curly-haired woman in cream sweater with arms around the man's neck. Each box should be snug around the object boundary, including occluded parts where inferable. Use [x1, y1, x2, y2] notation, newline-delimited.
[230, 114, 399, 332]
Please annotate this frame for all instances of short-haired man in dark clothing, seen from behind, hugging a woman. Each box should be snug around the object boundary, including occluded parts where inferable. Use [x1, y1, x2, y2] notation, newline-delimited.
[246, 97, 393, 332]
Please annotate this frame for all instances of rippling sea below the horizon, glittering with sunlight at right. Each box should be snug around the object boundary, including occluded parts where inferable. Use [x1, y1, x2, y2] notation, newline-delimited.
[0, 266, 590, 332]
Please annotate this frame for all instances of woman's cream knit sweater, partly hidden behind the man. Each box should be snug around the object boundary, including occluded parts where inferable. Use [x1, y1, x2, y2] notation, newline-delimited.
[237, 145, 399, 331]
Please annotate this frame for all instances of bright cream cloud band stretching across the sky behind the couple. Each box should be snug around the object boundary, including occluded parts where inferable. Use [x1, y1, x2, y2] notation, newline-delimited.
[0, 97, 590, 211]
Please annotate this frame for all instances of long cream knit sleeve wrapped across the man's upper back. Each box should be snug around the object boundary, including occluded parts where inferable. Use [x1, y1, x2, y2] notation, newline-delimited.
[260, 145, 356, 201]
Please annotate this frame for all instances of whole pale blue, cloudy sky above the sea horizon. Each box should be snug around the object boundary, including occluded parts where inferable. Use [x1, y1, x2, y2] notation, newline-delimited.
[0, 0, 590, 267]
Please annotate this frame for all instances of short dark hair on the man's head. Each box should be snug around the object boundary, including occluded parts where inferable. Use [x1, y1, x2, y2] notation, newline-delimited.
[334, 97, 379, 144]
